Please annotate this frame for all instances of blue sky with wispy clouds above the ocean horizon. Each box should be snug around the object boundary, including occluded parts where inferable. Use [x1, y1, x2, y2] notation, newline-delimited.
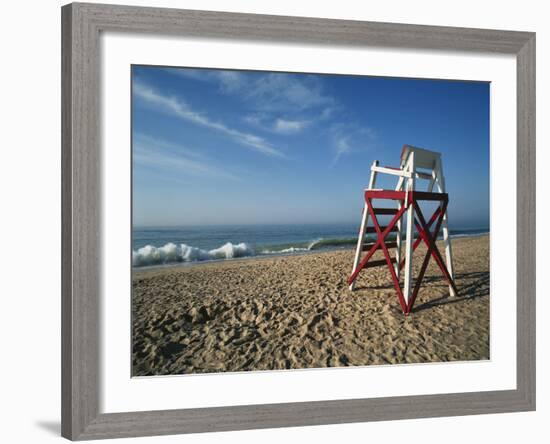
[132, 66, 490, 228]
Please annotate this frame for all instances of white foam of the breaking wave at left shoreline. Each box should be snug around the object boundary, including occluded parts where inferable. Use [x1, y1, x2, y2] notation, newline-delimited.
[132, 242, 254, 267]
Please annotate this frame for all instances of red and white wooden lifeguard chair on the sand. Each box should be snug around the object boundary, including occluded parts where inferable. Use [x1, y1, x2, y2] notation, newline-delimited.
[348, 145, 458, 315]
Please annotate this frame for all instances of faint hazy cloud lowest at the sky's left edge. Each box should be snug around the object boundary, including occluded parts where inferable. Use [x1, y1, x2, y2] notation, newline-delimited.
[132, 134, 239, 180]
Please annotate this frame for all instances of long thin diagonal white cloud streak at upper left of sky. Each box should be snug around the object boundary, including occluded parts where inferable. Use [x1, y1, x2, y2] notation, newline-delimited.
[133, 82, 285, 157]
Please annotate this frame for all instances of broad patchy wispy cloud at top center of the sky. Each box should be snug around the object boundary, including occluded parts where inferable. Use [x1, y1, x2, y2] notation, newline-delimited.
[158, 69, 376, 160]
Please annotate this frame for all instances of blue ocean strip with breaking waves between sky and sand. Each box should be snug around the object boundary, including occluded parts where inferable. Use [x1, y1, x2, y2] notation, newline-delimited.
[132, 223, 489, 267]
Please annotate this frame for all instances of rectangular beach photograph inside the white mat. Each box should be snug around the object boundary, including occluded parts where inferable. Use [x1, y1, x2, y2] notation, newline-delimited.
[130, 65, 491, 377]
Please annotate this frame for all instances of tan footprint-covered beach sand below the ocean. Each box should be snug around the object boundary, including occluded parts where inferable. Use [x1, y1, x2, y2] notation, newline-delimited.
[132, 236, 489, 376]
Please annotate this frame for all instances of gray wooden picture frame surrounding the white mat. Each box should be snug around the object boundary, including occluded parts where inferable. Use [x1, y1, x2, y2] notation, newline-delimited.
[62, 3, 535, 440]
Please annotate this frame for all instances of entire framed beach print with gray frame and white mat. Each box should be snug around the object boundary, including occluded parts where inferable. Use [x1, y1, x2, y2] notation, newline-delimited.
[62, 4, 535, 439]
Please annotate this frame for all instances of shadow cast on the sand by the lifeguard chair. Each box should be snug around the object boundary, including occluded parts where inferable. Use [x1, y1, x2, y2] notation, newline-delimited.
[356, 271, 490, 313]
